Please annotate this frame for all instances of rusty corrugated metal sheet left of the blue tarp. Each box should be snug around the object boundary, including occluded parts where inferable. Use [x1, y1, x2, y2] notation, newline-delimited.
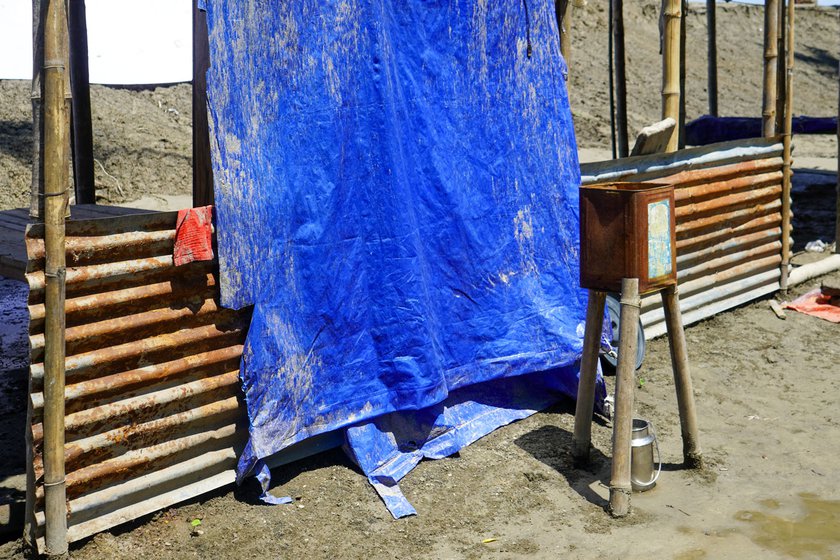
[26, 208, 250, 546]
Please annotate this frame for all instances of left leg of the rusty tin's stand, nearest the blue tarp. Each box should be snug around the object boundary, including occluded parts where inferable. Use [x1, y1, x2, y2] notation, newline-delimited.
[572, 290, 607, 464]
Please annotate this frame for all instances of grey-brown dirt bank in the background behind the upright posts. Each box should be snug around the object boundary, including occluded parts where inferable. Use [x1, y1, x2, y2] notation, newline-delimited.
[0, 0, 840, 210]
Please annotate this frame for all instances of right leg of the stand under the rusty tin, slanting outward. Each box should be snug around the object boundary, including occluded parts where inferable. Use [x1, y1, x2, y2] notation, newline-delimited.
[662, 286, 703, 468]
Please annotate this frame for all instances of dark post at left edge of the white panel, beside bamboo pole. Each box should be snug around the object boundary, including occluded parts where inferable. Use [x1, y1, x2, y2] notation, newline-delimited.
[68, 0, 96, 204]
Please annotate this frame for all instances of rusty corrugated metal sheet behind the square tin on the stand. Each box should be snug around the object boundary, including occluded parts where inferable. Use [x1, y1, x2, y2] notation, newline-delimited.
[581, 138, 784, 338]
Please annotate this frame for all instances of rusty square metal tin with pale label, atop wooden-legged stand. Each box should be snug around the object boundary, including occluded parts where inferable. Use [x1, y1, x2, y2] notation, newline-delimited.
[580, 183, 677, 294]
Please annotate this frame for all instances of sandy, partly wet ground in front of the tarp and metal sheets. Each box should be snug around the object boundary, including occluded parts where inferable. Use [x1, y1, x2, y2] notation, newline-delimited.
[0, 273, 840, 560]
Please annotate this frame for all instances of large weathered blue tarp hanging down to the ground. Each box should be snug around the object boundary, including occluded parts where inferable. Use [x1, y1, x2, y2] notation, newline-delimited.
[207, 0, 603, 515]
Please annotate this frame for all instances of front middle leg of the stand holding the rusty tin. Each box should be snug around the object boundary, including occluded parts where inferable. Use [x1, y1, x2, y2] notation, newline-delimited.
[610, 278, 642, 517]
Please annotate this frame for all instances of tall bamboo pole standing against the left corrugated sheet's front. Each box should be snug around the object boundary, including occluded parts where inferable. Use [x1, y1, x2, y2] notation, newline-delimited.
[42, 0, 70, 556]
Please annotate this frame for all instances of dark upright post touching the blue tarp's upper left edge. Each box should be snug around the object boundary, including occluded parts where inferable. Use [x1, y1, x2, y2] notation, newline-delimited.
[192, 0, 214, 206]
